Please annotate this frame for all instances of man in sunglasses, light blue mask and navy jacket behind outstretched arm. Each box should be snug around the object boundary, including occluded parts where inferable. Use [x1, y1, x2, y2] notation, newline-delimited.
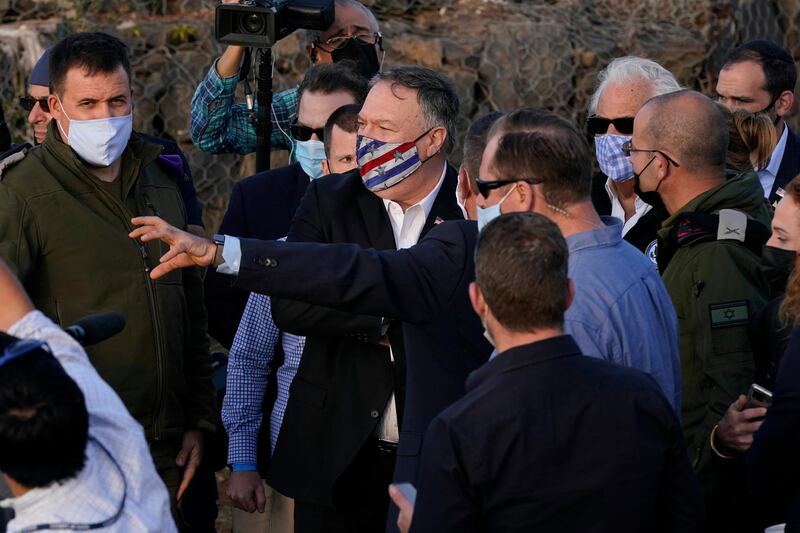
[205, 62, 368, 348]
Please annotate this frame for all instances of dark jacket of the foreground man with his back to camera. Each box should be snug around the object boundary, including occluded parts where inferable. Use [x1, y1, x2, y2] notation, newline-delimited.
[411, 335, 703, 533]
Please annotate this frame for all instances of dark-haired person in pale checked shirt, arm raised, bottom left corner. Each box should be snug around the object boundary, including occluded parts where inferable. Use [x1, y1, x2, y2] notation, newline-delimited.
[0, 261, 175, 532]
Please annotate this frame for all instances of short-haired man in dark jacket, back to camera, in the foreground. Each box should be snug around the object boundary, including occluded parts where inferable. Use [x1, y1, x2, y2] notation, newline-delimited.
[391, 212, 703, 533]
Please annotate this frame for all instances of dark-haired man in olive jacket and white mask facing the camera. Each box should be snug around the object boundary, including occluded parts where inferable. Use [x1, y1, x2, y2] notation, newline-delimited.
[0, 33, 216, 510]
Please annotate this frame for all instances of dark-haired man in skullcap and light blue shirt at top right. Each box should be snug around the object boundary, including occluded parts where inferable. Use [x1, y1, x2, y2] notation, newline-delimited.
[716, 39, 800, 205]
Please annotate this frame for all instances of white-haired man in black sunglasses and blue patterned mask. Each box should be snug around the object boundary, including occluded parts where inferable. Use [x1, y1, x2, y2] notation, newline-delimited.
[586, 56, 681, 263]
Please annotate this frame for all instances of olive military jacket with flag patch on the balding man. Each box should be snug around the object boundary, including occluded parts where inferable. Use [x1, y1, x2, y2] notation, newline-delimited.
[658, 172, 771, 485]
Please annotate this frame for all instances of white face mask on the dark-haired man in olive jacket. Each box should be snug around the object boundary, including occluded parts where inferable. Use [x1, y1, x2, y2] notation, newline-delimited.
[56, 95, 133, 167]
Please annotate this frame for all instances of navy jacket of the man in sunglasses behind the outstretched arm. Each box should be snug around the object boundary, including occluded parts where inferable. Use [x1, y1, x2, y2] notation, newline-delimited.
[205, 163, 308, 348]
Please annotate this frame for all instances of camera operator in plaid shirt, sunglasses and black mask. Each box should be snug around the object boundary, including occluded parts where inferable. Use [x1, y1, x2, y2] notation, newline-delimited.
[192, 0, 385, 156]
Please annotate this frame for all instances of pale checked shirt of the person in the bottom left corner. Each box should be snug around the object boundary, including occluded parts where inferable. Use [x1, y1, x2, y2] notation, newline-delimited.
[0, 311, 176, 533]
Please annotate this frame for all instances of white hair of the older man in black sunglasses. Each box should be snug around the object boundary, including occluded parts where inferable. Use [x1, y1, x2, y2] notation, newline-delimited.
[589, 56, 683, 115]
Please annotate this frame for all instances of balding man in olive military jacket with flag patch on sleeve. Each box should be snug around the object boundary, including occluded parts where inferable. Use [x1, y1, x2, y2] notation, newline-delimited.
[626, 91, 771, 531]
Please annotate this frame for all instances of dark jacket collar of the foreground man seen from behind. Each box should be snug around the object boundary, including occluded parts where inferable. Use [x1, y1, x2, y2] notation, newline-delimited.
[466, 335, 581, 391]
